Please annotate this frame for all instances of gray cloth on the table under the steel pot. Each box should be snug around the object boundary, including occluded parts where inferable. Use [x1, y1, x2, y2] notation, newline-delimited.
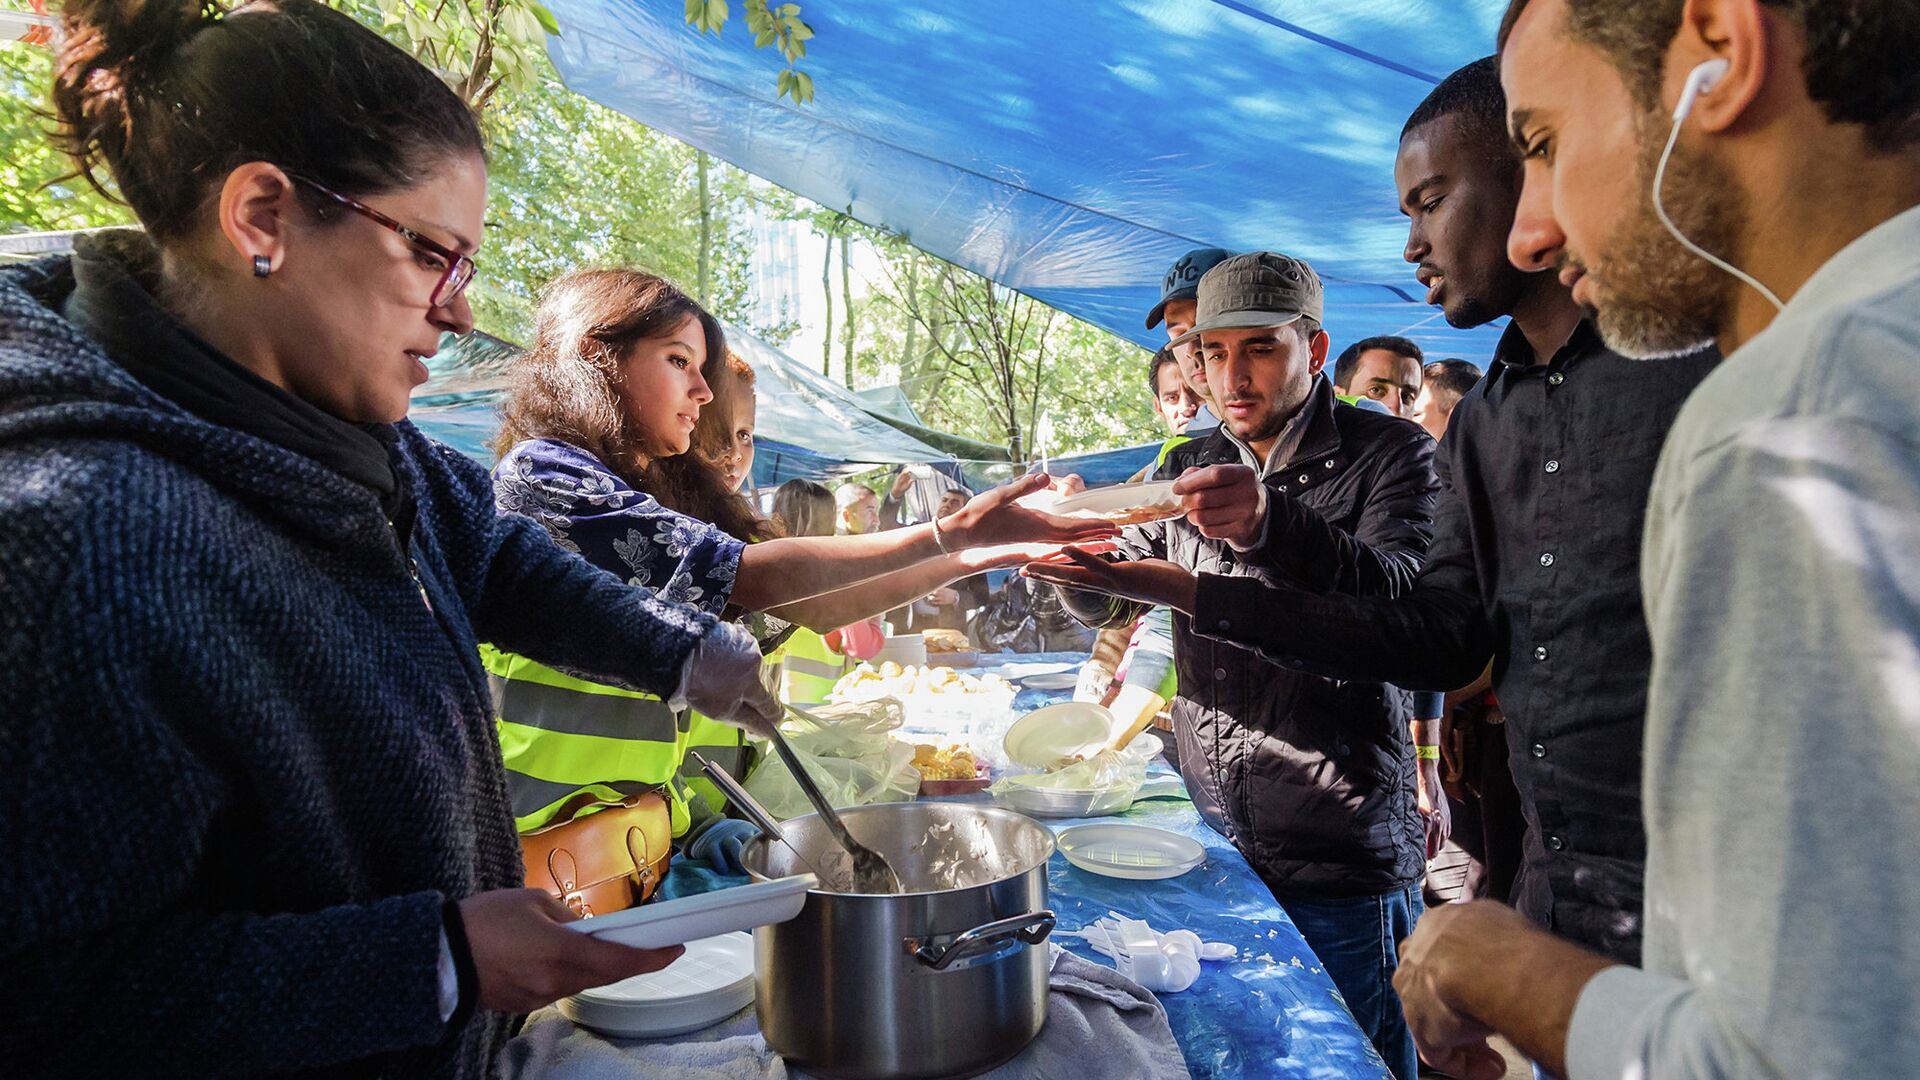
[505, 945, 1190, 1080]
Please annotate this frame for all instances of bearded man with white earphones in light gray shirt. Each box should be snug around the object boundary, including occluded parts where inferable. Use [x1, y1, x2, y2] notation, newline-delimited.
[1396, 0, 1920, 1080]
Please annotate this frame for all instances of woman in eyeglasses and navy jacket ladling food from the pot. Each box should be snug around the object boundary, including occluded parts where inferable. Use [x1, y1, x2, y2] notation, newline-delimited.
[0, 0, 778, 1078]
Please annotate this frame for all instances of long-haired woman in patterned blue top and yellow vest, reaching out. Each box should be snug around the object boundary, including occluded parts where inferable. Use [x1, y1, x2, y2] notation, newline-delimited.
[486, 269, 1114, 834]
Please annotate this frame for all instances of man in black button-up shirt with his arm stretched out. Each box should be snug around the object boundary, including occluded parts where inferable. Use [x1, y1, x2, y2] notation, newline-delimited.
[1035, 58, 1718, 963]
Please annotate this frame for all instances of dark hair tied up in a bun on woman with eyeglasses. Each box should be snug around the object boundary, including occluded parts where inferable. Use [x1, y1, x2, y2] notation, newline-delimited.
[54, 0, 482, 244]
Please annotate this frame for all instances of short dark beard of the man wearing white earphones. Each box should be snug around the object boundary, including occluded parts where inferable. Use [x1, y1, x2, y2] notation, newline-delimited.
[1561, 121, 1747, 359]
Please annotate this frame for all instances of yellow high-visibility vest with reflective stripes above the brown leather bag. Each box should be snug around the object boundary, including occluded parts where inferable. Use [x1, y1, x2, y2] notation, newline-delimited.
[480, 646, 691, 836]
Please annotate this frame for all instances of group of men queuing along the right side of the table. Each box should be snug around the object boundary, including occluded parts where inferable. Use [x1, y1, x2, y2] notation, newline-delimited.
[1029, 0, 1920, 1078]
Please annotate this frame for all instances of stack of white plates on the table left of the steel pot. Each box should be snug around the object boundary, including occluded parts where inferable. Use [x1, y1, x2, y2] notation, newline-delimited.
[559, 934, 753, 1040]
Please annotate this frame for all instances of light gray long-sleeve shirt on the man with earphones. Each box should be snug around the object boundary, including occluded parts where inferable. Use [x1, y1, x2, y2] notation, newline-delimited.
[1567, 208, 1920, 1080]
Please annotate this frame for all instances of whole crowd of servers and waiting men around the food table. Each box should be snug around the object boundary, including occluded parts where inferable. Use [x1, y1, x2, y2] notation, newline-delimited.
[0, 0, 1920, 1080]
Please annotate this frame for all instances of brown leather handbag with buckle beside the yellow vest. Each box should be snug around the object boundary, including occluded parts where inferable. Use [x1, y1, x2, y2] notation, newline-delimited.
[520, 792, 674, 917]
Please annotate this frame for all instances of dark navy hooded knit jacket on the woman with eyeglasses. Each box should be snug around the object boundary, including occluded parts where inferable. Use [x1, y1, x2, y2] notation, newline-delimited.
[0, 247, 712, 1078]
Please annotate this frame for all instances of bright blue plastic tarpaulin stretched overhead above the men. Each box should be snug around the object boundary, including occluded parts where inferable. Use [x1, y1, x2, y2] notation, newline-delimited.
[549, 0, 1505, 363]
